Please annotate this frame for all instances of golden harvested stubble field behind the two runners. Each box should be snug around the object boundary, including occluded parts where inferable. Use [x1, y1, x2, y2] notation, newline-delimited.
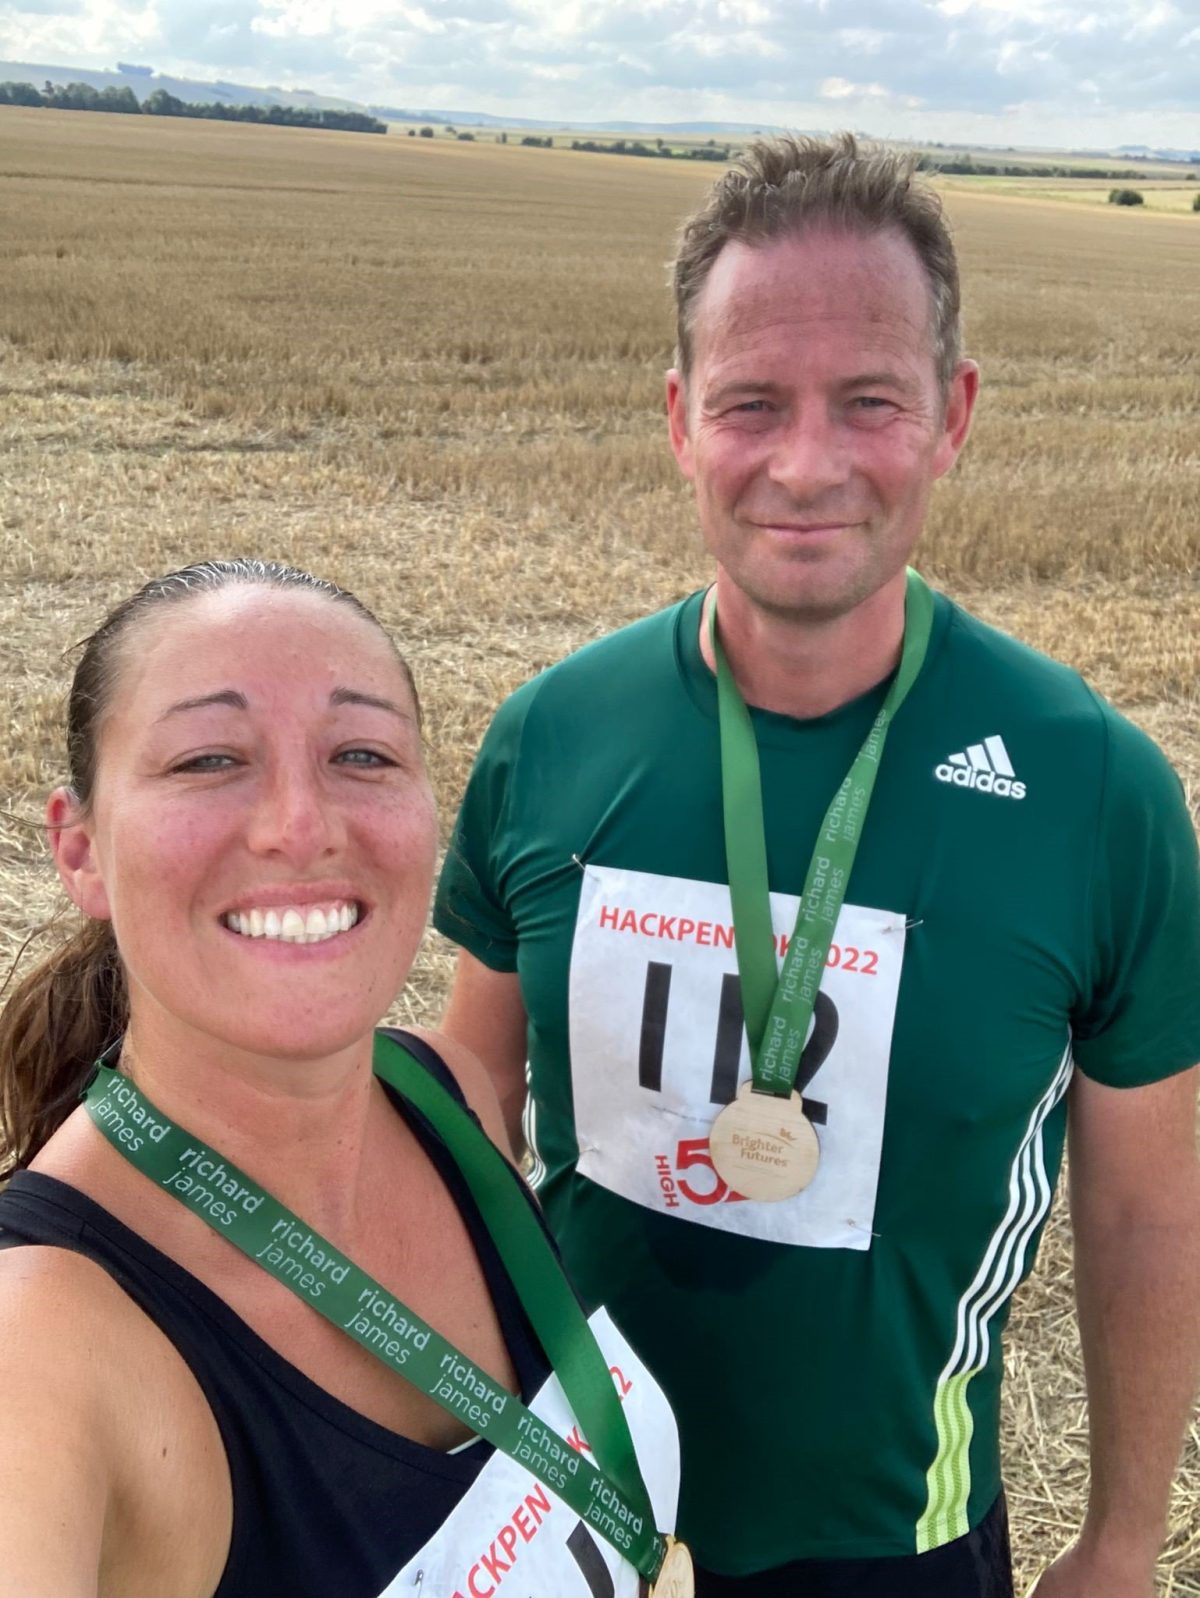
[0, 107, 1200, 1598]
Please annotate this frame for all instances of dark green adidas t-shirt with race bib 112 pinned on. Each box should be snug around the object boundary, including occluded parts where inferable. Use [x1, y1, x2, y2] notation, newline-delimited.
[435, 594, 1200, 1574]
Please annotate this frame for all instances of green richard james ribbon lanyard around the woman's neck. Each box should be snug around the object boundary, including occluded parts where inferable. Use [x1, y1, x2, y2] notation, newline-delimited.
[85, 1034, 666, 1582]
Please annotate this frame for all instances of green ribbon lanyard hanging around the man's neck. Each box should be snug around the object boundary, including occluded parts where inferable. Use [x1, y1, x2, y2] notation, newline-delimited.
[708, 567, 933, 1098]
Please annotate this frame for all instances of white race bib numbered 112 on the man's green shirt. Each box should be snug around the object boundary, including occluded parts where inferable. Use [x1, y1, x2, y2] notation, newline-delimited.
[570, 866, 904, 1250]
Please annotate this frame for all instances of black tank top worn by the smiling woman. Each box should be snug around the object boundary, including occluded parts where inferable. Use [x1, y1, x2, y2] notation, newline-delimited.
[0, 1034, 548, 1598]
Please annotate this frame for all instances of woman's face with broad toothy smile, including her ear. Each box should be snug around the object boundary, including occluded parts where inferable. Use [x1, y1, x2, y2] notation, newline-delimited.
[50, 585, 436, 1058]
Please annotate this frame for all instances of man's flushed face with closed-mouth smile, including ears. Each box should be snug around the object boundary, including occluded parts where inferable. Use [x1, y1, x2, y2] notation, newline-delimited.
[666, 229, 978, 620]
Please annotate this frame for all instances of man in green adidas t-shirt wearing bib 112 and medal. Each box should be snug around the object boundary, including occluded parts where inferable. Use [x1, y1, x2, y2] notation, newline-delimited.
[436, 136, 1200, 1598]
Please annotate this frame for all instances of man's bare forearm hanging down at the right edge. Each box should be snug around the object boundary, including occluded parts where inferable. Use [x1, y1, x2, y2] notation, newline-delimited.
[1035, 1069, 1200, 1598]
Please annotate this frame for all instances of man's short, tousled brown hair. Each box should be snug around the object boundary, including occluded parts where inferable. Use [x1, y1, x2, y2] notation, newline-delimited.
[671, 133, 962, 395]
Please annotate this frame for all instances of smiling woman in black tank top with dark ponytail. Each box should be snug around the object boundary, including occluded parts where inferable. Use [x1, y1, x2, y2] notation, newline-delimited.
[0, 561, 677, 1598]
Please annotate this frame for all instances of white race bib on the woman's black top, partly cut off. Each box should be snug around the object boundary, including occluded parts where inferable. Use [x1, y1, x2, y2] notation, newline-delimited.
[379, 1309, 679, 1598]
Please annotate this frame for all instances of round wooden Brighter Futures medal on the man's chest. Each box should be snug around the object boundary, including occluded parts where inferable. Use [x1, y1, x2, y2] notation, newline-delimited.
[708, 1082, 821, 1203]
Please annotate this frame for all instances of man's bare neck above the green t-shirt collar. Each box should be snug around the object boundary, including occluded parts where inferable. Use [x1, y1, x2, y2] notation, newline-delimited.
[700, 567, 904, 721]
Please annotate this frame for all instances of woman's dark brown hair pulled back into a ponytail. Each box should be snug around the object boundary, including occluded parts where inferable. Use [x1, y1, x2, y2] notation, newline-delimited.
[0, 558, 417, 1178]
